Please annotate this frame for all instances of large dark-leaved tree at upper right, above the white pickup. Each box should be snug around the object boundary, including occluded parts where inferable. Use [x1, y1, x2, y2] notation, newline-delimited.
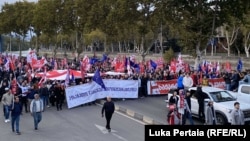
[165, 0, 249, 68]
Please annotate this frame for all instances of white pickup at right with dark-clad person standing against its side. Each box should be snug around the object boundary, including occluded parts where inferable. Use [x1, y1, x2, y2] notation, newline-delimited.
[168, 86, 250, 125]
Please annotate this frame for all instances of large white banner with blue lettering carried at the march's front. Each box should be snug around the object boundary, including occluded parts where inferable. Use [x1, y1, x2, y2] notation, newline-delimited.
[65, 79, 138, 108]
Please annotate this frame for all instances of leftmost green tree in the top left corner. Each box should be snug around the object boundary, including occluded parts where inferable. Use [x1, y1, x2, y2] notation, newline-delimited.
[0, 1, 34, 55]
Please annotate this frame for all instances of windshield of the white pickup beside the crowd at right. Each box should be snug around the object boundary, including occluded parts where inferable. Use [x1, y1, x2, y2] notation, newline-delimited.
[210, 91, 235, 102]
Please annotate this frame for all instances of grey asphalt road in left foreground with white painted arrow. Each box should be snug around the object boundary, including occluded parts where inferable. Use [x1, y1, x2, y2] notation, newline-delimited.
[0, 104, 144, 141]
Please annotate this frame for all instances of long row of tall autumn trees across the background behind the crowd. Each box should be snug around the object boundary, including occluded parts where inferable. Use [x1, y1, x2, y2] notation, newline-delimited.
[0, 0, 250, 61]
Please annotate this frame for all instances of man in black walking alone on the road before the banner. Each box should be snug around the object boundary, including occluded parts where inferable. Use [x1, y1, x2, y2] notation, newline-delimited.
[102, 96, 115, 132]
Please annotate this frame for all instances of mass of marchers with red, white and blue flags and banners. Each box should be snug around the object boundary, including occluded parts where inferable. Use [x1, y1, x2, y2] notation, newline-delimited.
[0, 49, 244, 108]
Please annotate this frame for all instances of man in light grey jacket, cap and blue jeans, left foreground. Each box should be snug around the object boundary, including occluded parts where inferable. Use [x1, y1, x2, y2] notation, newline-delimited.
[30, 94, 44, 130]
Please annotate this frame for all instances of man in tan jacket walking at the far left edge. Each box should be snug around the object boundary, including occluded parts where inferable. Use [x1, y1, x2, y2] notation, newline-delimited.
[2, 87, 14, 123]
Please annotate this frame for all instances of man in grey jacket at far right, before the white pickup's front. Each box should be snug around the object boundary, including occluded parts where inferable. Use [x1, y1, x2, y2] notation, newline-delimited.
[231, 102, 245, 125]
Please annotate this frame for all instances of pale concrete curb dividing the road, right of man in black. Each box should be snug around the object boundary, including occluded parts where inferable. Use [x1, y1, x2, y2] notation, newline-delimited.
[97, 100, 164, 125]
